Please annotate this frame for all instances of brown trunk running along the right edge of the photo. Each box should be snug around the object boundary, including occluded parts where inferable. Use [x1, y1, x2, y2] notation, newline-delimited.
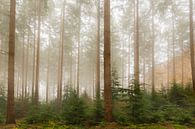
[189, 0, 195, 92]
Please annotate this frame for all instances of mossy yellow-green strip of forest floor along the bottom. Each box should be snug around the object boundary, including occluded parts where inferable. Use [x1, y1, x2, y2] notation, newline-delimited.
[0, 123, 195, 129]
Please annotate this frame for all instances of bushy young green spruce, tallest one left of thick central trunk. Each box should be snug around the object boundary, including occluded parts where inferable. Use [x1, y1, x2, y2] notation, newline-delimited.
[62, 89, 86, 125]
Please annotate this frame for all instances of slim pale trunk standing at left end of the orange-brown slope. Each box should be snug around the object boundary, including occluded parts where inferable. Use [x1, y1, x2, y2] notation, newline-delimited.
[151, 0, 155, 94]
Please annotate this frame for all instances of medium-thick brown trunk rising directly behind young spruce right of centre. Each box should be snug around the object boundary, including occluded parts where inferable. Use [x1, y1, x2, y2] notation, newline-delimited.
[134, 0, 139, 84]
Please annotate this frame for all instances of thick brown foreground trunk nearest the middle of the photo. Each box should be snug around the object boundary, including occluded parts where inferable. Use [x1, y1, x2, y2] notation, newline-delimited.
[104, 0, 112, 122]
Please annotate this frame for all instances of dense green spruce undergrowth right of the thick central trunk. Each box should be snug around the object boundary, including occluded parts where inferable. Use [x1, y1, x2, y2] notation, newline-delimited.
[113, 84, 195, 124]
